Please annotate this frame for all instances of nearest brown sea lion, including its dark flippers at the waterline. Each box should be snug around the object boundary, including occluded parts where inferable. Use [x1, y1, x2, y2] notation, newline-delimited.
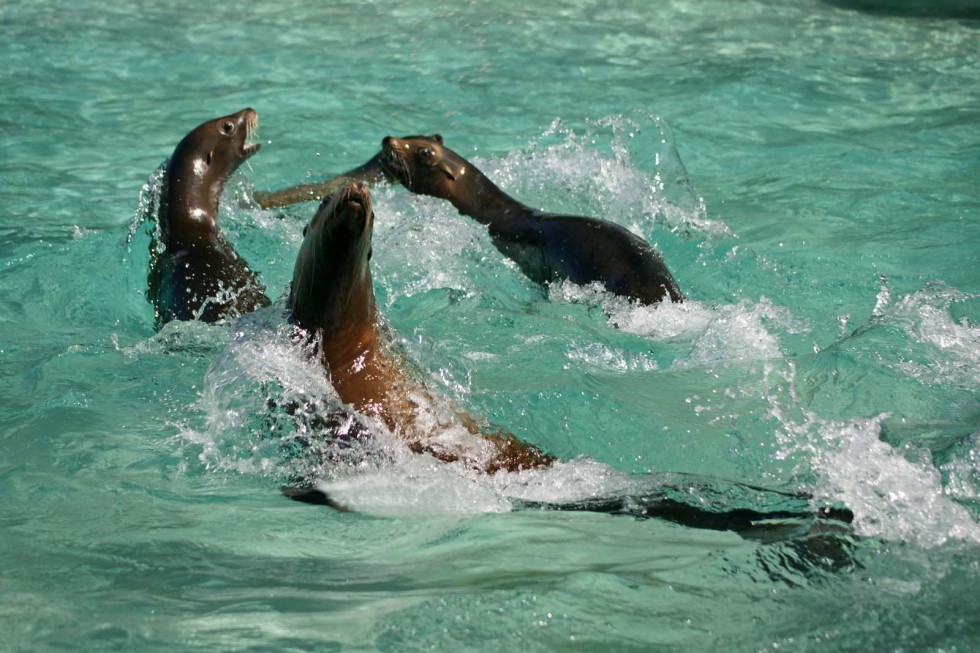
[283, 182, 853, 539]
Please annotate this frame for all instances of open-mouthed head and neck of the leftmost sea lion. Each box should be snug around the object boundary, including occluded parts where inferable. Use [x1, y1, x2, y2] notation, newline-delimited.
[165, 109, 261, 222]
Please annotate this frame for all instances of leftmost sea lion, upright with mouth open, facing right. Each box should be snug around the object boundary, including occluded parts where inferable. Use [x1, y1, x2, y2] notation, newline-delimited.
[147, 109, 269, 328]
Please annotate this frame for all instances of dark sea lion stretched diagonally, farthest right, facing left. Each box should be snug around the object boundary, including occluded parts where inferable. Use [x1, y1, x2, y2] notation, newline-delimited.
[381, 134, 684, 304]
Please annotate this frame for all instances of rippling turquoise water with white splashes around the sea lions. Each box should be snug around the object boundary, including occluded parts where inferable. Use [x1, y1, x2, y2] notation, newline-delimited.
[0, 0, 980, 651]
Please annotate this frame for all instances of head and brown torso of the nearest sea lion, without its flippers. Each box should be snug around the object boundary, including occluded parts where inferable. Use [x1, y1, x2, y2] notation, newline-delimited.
[288, 182, 554, 474]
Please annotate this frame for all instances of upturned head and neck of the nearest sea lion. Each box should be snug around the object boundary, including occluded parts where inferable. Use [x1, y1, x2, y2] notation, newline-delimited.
[289, 182, 375, 333]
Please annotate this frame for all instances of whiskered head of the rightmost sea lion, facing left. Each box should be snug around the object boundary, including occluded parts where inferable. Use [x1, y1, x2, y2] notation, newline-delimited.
[381, 134, 468, 199]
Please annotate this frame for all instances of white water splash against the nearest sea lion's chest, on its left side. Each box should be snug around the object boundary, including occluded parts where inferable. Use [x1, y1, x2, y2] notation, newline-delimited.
[170, 306, 392, 485]
